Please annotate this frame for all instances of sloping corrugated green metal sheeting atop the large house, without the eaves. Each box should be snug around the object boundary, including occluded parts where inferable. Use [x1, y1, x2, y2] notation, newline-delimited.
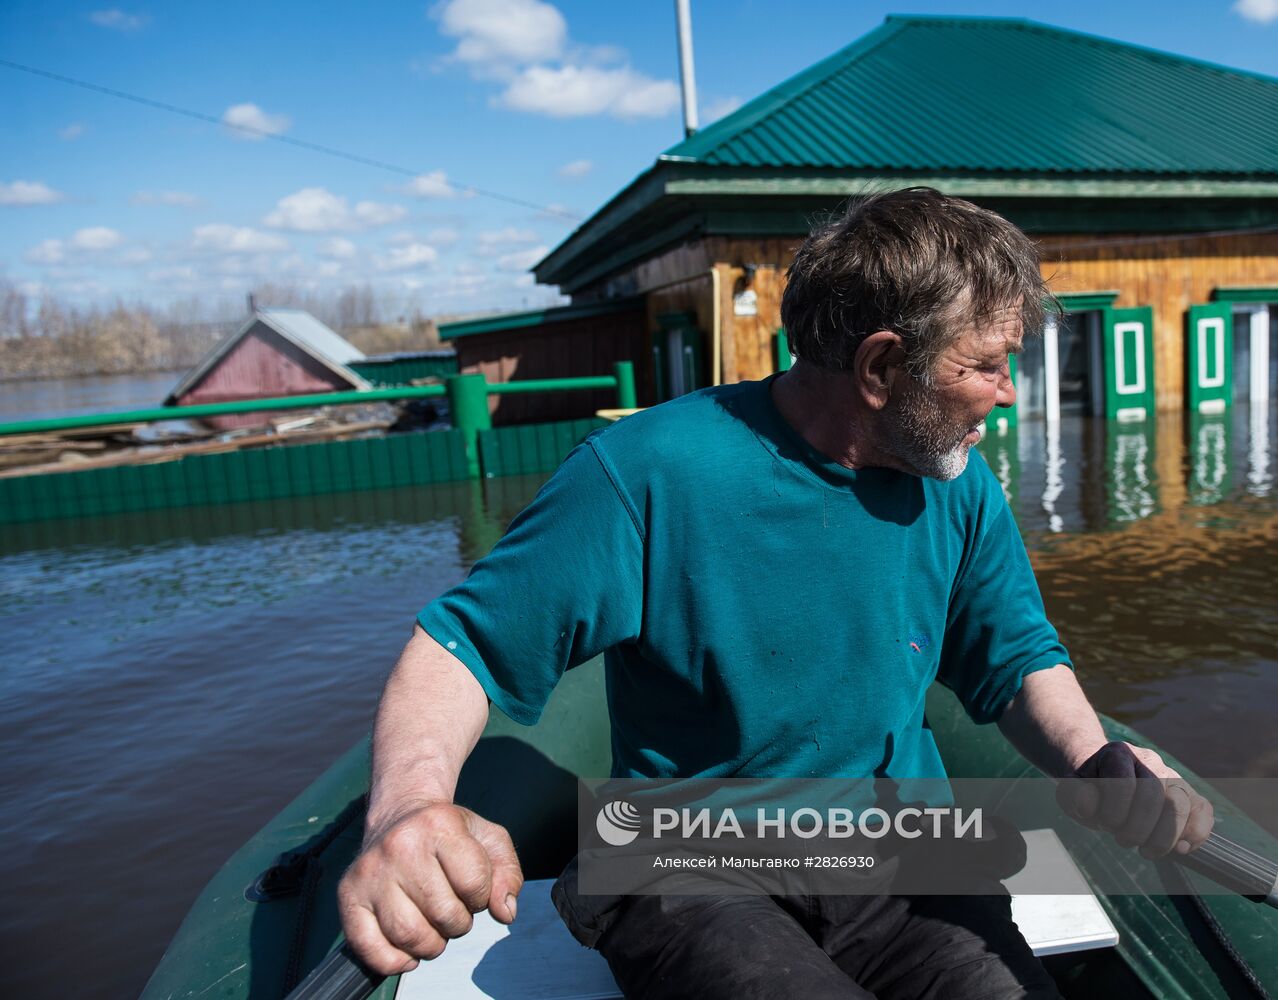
[662, 17, 1278, 175]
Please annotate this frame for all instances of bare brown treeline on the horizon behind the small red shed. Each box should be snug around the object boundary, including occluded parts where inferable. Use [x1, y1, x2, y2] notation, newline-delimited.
[0, 281, 440, 381]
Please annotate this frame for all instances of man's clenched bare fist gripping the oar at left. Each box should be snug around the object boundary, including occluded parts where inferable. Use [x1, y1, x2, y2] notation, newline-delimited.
[337, 802, 524, 976]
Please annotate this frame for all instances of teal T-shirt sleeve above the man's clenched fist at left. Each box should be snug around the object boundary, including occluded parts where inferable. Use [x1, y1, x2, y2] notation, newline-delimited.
[418, 441, 643, 725]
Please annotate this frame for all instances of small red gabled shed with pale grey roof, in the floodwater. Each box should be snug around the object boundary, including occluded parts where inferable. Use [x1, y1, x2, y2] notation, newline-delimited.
[164, 309, 372, 430]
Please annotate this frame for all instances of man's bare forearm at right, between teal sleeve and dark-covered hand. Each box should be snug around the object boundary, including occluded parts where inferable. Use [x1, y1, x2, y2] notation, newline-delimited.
[998, 664, 1105, 777]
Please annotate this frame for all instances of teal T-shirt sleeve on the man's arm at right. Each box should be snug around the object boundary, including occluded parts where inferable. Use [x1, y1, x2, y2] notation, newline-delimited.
[938, 488, 1072, 723]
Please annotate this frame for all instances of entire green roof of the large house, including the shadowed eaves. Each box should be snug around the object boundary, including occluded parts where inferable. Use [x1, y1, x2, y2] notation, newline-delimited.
[533, 15, 1278, 294]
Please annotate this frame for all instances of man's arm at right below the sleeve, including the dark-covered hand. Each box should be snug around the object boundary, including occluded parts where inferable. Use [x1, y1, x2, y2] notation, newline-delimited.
[998, 664, 1213, 858]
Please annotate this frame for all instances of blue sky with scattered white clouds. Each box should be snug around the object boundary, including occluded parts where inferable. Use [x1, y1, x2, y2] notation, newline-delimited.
[0, 0, 1278, 315]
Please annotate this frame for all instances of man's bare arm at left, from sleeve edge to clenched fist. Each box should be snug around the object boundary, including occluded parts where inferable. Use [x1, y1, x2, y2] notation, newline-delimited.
[337, 625, 523, 976]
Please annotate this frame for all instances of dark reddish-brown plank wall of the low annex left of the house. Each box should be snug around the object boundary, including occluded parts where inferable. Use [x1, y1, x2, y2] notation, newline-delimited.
[455, 309, 652, 427]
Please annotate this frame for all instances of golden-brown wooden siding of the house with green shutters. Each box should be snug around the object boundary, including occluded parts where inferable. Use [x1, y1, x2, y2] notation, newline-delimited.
[594, 234, 1278, 409]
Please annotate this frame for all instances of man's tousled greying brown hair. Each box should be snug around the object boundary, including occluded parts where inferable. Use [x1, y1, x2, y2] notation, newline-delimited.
[781, 188, 1054, 382]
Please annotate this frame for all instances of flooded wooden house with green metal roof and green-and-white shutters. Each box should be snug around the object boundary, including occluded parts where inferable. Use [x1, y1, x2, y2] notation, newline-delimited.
[460, 17, 1278, 429]
